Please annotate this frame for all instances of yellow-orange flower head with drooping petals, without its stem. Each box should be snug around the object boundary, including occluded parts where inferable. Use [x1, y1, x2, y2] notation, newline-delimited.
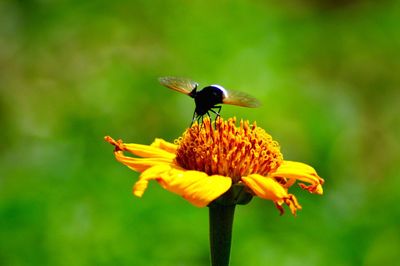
[105, 118, 324, 214]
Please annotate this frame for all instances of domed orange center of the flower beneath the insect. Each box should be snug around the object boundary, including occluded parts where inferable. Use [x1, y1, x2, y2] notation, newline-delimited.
[175, 118, 283, 183]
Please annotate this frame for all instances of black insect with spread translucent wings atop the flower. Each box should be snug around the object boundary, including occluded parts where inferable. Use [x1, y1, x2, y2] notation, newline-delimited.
[159, 77, 260, 123]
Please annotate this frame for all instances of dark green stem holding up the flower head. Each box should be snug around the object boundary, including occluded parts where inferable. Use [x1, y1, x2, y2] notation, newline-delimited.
[209, 202, 236, 266]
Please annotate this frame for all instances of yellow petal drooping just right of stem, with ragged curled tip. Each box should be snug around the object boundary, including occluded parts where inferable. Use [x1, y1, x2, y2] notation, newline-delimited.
[242, 174, 301, 215]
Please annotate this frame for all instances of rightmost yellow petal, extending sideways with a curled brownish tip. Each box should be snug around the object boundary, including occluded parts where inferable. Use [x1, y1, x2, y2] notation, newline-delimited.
[270, 161, 324, 194]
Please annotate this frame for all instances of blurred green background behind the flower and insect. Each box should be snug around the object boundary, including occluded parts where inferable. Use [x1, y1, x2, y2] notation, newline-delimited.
[0, 0, 400, 266]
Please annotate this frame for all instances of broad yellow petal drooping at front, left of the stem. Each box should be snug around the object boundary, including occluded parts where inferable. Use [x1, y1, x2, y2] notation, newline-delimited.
[134, 164, 232, 207]
